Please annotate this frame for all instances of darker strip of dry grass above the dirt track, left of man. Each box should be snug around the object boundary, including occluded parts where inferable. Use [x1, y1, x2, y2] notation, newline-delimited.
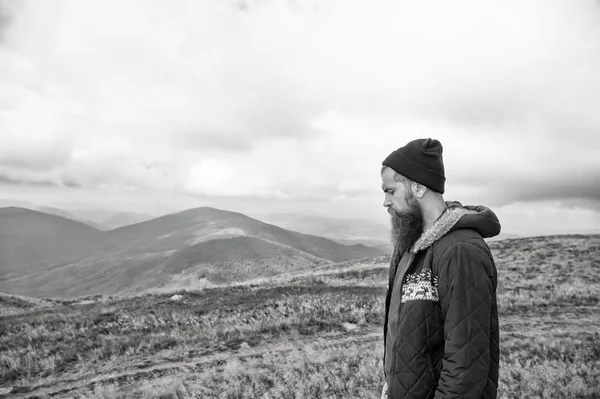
[0, 287, 383, 392]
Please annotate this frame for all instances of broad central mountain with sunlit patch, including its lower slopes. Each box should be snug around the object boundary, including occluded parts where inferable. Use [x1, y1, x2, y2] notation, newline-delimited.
[0, 208, 381, 297]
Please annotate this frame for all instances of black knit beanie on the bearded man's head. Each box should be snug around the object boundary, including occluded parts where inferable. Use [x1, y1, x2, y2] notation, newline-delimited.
[383, 139, 446, 194]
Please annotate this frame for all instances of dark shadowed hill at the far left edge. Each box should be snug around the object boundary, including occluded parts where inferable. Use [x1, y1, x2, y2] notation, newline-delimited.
[0, 207, 102, 284]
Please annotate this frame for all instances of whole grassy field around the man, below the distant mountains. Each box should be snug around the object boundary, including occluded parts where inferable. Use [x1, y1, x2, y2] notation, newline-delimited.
[0, 236, 600, 398]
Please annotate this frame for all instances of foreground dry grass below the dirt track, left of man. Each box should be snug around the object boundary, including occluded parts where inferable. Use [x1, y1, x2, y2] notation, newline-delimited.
[79, 342, 382, 398]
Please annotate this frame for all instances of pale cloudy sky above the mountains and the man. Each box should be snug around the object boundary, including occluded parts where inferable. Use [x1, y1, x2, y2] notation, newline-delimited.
[0, 0, 600, 234]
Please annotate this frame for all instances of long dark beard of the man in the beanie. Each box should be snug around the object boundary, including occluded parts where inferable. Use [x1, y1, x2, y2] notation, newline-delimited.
[391, 200, 423, 255]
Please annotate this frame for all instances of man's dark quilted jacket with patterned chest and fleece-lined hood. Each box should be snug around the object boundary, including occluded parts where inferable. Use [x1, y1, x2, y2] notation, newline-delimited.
[383, 202, 500, 399]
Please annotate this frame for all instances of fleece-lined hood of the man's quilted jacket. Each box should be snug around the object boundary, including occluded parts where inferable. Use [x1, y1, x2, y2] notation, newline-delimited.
[410, 201, 500, 253]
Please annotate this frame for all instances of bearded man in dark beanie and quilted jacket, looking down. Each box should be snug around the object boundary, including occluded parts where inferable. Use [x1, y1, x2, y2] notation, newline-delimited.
[381, 138, 500, 399]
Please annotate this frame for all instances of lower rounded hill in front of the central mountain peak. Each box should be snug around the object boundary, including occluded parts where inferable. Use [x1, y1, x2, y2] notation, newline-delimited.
[8, 237, 327, 298]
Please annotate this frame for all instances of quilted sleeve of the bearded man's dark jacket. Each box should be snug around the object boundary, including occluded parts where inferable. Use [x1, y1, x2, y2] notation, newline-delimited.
[435, 242, 494, 399]
